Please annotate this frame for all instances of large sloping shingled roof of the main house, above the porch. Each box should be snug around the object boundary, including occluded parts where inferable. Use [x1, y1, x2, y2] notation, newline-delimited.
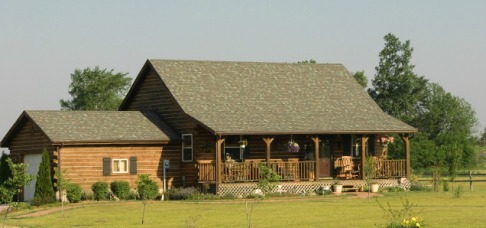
[149, 60, 416, 134]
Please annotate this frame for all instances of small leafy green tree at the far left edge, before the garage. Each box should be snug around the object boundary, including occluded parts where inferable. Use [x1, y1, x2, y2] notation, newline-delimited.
[0, 158, 34, 227]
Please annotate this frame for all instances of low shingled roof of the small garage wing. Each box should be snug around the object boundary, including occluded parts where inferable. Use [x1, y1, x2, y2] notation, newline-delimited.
[25, 111, 175, 143]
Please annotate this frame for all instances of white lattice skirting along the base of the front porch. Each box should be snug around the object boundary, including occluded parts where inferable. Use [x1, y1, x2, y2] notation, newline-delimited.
[216, 178, 410, 196]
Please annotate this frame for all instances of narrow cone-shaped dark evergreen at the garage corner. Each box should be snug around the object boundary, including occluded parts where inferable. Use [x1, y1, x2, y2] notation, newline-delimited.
[33, 148, 56, 205]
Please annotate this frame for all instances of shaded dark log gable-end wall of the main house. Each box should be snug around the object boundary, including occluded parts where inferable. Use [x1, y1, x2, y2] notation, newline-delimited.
[121, 67, 203, 186]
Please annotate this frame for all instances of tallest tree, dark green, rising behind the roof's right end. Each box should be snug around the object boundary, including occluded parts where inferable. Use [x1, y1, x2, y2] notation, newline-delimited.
[368, 33, 427, 126]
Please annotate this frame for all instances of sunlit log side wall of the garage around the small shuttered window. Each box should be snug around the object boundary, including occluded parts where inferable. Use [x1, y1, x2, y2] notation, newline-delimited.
[59, 145, 165, 191]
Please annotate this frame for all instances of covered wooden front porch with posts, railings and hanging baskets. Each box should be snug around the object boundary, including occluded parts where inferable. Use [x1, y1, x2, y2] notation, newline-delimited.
[196, 134, 410, 191]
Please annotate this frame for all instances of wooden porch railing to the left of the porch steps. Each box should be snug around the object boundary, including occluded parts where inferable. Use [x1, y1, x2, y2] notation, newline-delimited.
[197, 161, 315, 183]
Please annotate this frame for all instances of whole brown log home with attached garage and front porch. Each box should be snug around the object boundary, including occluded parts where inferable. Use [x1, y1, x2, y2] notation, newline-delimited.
[2, 60, 417, 200]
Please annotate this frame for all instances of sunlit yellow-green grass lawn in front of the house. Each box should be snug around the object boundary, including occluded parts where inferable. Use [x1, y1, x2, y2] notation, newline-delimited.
[3, 182, 486, 227]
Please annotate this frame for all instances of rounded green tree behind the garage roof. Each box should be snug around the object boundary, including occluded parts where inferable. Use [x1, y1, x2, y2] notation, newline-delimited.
[60, 67, 131, 111]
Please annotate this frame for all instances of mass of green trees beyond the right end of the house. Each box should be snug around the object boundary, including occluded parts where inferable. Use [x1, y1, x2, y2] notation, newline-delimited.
[368, 34, 481, 172]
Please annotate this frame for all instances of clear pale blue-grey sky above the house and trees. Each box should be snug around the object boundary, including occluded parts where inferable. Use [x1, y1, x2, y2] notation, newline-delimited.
[0, 0, 486, 148]
